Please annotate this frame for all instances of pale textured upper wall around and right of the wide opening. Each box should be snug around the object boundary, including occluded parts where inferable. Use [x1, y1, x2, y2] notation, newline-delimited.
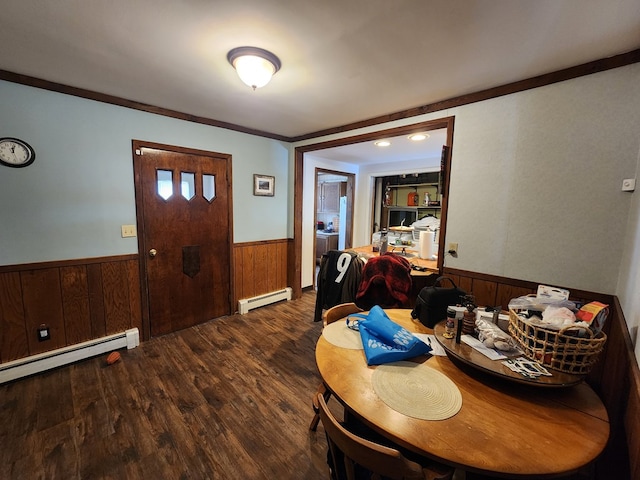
[295, 64, 640, 360]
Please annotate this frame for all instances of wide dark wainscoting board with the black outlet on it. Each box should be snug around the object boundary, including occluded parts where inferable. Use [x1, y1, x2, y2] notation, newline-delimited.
[20, 268, 66, 355]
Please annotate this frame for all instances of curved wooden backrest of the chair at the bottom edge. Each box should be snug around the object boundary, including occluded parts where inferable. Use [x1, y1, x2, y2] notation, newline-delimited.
[316, 394, 424, 480]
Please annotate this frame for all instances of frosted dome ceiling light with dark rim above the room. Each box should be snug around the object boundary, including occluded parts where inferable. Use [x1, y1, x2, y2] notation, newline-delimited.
[227, 47, 282, 90]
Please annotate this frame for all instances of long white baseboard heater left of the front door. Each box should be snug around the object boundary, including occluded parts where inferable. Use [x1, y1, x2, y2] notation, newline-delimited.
[0, 328, 140, 384]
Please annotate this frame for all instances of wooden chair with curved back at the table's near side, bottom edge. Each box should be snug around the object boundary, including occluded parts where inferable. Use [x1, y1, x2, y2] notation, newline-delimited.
[317, 394, 454, 480]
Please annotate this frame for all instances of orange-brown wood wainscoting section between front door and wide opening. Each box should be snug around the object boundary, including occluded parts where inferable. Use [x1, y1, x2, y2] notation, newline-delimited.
[233, 238, 289, 307]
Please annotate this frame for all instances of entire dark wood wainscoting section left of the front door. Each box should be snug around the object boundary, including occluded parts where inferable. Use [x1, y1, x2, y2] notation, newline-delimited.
[0, 254, 142, 363]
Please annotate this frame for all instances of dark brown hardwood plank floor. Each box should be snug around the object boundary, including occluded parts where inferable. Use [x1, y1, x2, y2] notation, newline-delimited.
[0, 292, 337, 480]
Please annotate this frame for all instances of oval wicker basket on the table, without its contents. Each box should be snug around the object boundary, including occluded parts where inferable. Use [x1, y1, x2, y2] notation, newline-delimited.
[509, 309, 607, 375]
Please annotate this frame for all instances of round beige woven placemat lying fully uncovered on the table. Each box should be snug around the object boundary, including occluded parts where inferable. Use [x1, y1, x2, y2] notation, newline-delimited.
[371, 362, 462, 420]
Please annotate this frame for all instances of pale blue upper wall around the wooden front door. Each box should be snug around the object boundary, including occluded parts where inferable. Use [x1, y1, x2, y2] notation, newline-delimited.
[0, 81, 293, 265]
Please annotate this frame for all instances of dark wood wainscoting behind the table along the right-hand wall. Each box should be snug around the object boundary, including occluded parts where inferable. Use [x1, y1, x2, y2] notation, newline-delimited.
[444, 268, 640, 480]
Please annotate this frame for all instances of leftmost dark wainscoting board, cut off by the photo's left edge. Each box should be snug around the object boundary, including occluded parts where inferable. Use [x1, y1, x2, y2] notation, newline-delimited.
[0, 272, 29, 363]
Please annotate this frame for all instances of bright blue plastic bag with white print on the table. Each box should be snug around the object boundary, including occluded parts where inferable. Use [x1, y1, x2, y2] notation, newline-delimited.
[347, 305, 431, 365]
